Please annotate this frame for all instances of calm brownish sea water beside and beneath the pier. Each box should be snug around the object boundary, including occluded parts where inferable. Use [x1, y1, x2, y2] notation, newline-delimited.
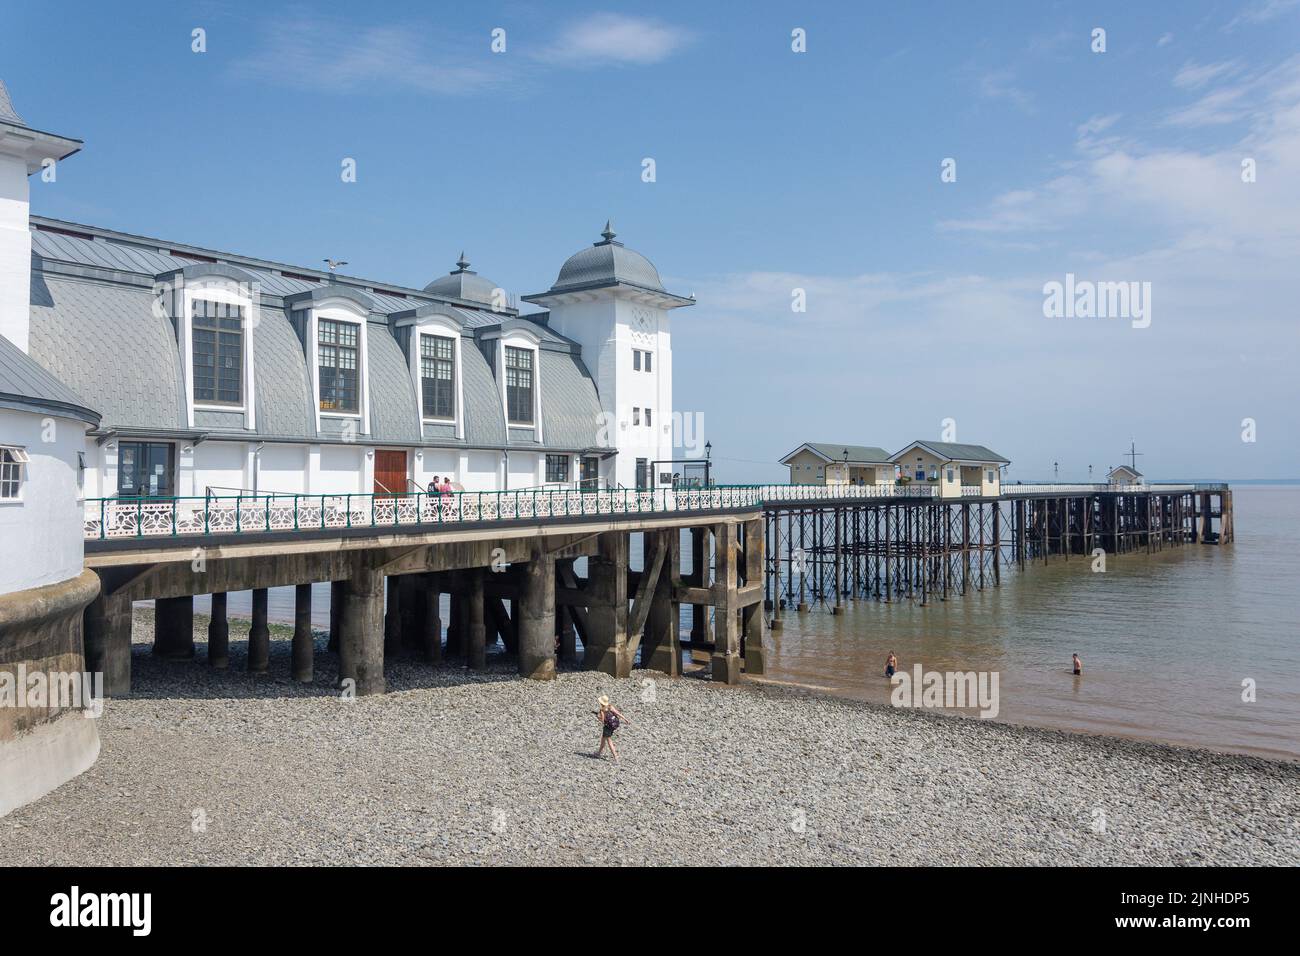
[195, 485, 1300, 760]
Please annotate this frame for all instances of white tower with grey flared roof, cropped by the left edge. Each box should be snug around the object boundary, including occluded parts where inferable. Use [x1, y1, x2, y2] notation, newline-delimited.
[0, 79, 82, 352]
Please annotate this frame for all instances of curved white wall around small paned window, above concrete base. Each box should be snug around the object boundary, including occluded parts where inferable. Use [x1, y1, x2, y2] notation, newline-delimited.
[0, 408, 86, 594]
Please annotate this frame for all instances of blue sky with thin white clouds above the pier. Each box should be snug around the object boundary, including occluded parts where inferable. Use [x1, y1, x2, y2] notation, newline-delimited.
[0, 0, 1300, 480]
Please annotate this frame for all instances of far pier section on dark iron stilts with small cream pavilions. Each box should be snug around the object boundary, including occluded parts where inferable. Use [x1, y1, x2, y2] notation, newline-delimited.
[761, 441, 1234, 621]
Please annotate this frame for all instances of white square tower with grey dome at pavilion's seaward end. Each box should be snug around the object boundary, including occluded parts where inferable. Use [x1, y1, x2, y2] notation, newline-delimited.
[524, 222, 696, 488]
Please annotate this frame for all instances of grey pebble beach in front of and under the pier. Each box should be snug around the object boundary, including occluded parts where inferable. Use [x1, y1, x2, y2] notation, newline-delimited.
[0, 614, 1300, 866]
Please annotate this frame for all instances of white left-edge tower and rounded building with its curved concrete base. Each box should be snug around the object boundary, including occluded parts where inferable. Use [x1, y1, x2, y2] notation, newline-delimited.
[0, 82, 100, 816]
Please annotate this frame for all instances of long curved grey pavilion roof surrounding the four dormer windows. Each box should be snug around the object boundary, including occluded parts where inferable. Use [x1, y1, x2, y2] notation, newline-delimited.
[31, 217, 599, 450]
